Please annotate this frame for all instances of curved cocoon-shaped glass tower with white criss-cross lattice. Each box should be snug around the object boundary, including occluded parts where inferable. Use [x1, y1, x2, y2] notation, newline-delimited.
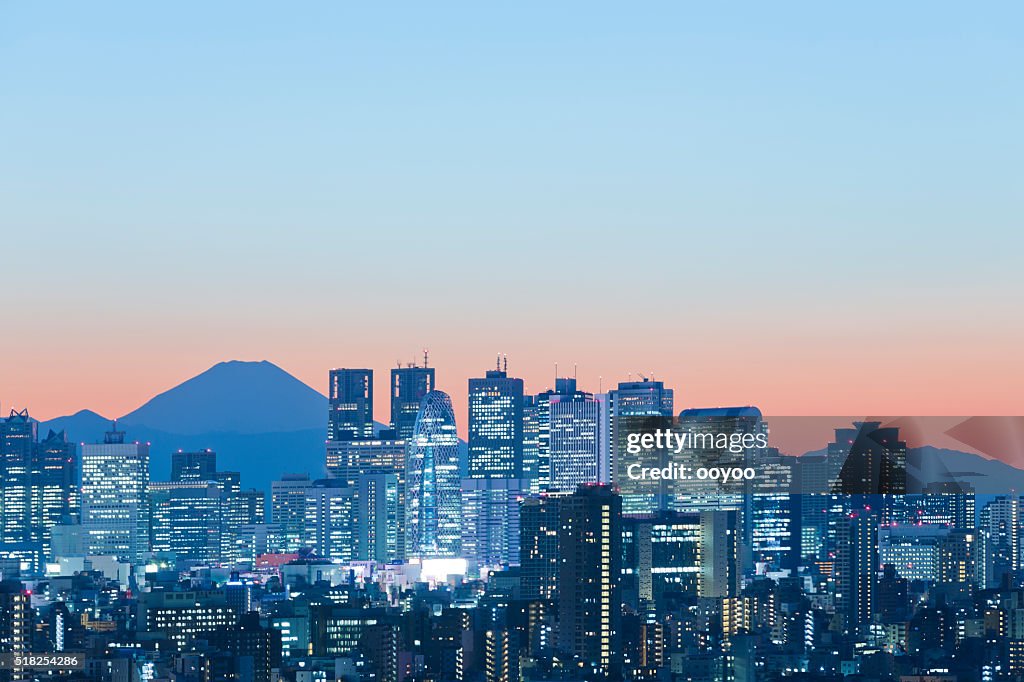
[406, 391, 462, 559]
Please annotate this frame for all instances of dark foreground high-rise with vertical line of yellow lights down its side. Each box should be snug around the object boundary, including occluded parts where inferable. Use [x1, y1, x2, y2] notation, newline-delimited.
[558, 484, 623, 678]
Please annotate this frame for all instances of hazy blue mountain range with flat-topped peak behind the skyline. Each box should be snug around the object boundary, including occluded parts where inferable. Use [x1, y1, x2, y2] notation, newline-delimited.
[40, 360, 1024, 495]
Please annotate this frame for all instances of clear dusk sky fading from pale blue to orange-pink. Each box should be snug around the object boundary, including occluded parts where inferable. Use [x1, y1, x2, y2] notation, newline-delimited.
[0, 1, 1024, 419]
